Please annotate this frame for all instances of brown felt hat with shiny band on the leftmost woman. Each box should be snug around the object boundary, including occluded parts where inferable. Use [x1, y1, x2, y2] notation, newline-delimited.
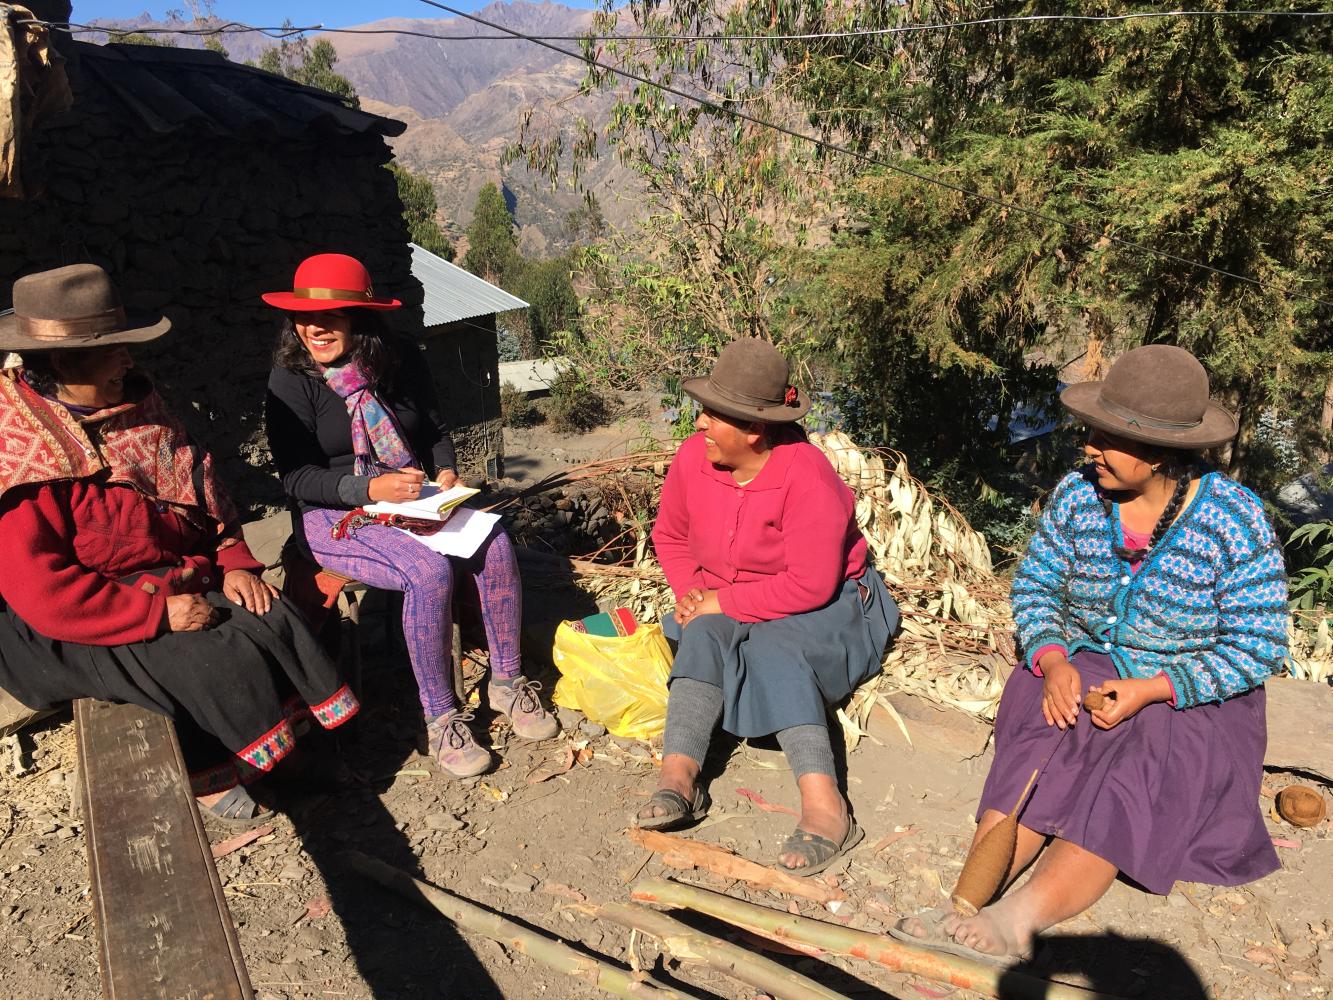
[0, 264, 171, 351]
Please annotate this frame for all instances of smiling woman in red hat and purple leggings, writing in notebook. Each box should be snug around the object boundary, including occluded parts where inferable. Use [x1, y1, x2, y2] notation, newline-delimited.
[264, 253, 559, 777]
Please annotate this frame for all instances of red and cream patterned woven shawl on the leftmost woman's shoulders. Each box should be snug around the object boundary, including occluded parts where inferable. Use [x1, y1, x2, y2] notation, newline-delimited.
[0, 368, 240, 547]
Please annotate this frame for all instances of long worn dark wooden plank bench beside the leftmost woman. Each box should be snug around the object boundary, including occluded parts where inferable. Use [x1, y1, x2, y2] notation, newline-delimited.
[75, 699, 253, 1000]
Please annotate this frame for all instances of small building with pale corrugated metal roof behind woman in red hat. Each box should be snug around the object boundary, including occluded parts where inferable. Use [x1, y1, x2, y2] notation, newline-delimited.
[408, 243, 528, 479]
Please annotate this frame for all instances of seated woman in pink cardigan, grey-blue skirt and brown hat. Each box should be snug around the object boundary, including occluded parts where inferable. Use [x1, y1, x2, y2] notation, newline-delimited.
[633, 339, 898, 875]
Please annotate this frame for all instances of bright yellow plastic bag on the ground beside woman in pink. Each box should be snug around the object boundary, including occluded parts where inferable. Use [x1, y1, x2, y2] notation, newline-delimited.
[552, 621, 670, 740]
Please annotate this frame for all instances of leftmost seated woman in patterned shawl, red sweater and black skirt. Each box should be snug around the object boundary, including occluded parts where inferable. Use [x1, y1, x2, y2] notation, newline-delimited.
[0, 264, 357, 821]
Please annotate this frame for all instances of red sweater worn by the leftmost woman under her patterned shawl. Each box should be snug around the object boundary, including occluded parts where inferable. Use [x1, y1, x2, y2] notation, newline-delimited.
[0, 480, 264, 645]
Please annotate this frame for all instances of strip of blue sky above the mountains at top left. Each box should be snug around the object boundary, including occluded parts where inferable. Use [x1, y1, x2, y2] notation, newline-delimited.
[73, 0, 593, 28]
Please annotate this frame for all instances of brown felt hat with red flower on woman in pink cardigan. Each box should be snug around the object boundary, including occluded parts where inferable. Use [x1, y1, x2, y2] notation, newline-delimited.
[681, 337, 810, 424]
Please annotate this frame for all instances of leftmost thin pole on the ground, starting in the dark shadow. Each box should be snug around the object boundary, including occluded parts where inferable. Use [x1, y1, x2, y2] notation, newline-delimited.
[345, 851, 688, 1000]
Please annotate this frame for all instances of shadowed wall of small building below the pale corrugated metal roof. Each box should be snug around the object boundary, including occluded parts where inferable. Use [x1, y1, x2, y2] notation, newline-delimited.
[421, 313, 504, 479]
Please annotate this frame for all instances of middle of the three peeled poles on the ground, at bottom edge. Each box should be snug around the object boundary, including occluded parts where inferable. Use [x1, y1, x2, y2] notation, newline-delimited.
[597, 903, 848, 1000]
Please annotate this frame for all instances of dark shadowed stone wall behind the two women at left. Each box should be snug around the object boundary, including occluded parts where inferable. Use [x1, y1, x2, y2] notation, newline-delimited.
[0, 45, 421, 513]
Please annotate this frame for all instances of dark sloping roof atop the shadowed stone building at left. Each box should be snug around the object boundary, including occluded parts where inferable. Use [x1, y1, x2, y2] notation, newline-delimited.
[72, 41, 407, 139]
